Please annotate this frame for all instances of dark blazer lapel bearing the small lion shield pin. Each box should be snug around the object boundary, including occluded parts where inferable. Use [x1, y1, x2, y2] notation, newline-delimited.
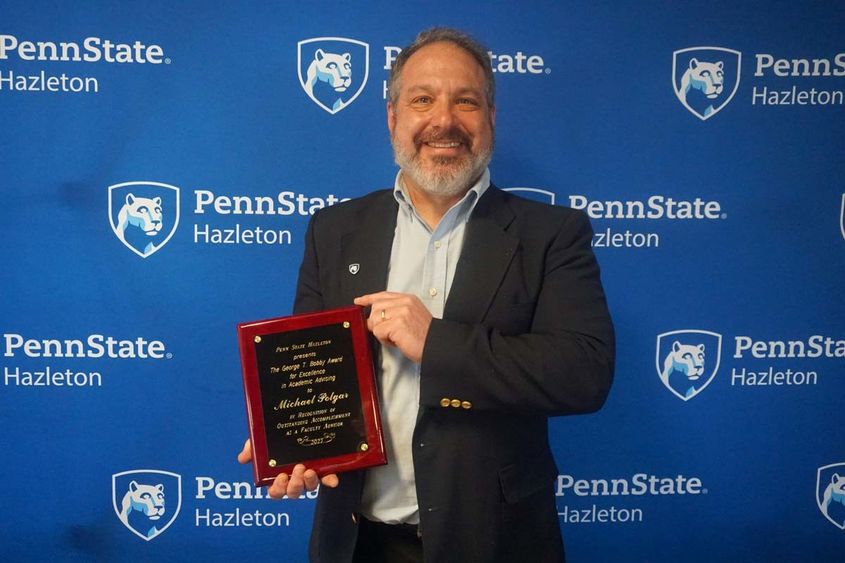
[341, 190, 398, 303]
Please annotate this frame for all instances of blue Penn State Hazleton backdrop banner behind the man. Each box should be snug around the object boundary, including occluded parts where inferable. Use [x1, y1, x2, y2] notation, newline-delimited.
[0, 0, 845, 562]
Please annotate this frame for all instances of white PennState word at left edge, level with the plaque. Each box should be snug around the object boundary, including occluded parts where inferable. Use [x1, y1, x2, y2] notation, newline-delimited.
[3, 333, 170, 360]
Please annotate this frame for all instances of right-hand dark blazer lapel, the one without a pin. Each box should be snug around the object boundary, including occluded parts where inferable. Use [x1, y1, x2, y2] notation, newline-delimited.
[443, 185, 519, 323]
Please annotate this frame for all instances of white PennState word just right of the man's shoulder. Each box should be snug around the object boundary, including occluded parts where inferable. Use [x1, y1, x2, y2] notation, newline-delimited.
[569, 195, 727, 220]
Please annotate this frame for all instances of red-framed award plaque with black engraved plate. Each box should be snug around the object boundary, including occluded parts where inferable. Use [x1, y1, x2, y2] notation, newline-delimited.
[238, 307, 387, 486]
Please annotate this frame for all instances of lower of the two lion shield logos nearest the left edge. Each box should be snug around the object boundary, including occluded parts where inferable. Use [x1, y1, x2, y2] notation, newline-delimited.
[112, 469, 182, 541]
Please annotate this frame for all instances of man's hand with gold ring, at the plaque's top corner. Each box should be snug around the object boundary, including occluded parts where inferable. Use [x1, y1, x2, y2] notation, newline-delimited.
[355, 291, 431, 363]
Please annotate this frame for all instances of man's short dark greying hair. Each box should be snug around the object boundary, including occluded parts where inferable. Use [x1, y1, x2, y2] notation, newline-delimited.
[387, 27, 496, 108]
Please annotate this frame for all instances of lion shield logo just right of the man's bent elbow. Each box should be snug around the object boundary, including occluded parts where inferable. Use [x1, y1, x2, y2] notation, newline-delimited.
[657, 330, 722, 401]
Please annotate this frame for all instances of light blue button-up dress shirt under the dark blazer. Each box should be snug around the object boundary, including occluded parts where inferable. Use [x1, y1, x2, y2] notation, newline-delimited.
[362, 170, 490, 524]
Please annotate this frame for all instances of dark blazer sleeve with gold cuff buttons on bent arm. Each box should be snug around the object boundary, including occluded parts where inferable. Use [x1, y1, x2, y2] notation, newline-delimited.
[420, 212, 615, 416]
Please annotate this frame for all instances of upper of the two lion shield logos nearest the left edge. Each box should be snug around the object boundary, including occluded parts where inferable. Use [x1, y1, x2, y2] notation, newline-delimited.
[109, 182, 179, 258]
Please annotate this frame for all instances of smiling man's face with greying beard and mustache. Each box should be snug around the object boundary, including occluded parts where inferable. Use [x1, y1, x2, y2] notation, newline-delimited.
[387, 42, 496, 197]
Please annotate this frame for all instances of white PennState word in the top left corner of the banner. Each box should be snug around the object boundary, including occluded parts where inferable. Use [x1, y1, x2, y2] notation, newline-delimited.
[0, 35, 170, 65]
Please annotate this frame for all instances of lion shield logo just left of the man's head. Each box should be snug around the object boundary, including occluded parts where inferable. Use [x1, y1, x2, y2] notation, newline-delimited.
[296, 37, 370, 115]
